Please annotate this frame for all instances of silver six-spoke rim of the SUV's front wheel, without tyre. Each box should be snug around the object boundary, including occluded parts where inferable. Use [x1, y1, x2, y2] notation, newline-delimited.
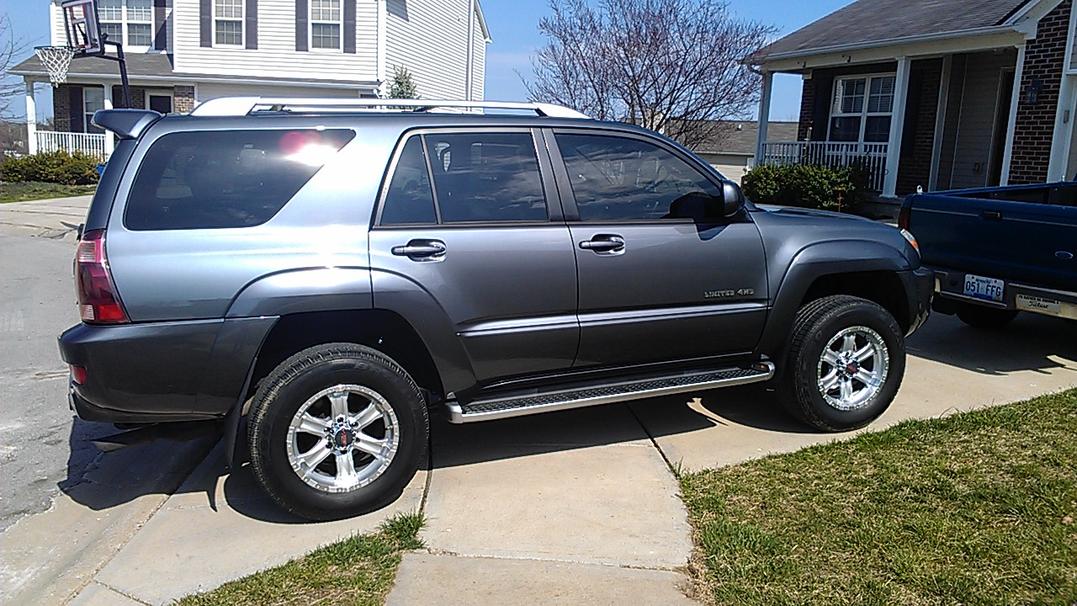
[817, 326, 890, 410]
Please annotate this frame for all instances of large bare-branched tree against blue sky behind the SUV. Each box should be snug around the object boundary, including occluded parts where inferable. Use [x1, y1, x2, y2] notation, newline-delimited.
[524, 0, 777, 146]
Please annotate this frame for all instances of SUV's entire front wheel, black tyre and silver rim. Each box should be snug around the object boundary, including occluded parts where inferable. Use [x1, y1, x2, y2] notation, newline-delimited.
[779, 295, 905, 432]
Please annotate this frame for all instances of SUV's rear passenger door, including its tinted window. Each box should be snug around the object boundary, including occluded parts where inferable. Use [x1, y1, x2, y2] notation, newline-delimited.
[370, 128, 579, 382]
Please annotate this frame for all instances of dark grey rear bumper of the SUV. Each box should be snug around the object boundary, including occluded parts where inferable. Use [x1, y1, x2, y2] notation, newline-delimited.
[59, 318, 276, 423]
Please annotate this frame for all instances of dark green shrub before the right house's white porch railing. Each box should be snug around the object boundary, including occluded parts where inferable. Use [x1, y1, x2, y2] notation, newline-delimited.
[742, 164, 868, 211]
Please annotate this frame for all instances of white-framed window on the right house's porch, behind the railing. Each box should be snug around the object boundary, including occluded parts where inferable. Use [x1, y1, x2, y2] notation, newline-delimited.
[829, 74, 895, 143]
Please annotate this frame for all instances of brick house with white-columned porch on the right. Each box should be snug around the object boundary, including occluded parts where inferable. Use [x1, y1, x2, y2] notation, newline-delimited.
[750, 0, 1077, 197]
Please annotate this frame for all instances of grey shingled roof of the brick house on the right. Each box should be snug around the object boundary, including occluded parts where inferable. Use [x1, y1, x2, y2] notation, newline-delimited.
[751, 0, 1036, 64]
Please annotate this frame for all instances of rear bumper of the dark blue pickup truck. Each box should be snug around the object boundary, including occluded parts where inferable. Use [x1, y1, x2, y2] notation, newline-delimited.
[933, 268, 1077, 320]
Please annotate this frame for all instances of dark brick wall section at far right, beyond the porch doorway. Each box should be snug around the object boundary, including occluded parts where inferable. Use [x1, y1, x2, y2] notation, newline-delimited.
[1009, 0, 1073, 184]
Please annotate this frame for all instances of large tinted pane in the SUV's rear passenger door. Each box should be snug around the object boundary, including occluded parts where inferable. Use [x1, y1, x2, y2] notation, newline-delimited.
[425, 132, 548, 223]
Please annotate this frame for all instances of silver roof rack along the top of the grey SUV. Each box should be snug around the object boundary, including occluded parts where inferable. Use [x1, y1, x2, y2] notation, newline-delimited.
[191, 97, 590, 119]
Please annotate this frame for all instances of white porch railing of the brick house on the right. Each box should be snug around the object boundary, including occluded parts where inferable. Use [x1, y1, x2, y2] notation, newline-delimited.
[763, 141, 889, 192]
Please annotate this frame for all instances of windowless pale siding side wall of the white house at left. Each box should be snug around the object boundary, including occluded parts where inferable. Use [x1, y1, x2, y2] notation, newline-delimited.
[386, 0, 478, 99]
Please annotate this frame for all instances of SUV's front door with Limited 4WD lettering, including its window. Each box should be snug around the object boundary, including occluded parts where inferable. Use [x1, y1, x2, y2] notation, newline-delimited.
[551, 130, 767, 366]
